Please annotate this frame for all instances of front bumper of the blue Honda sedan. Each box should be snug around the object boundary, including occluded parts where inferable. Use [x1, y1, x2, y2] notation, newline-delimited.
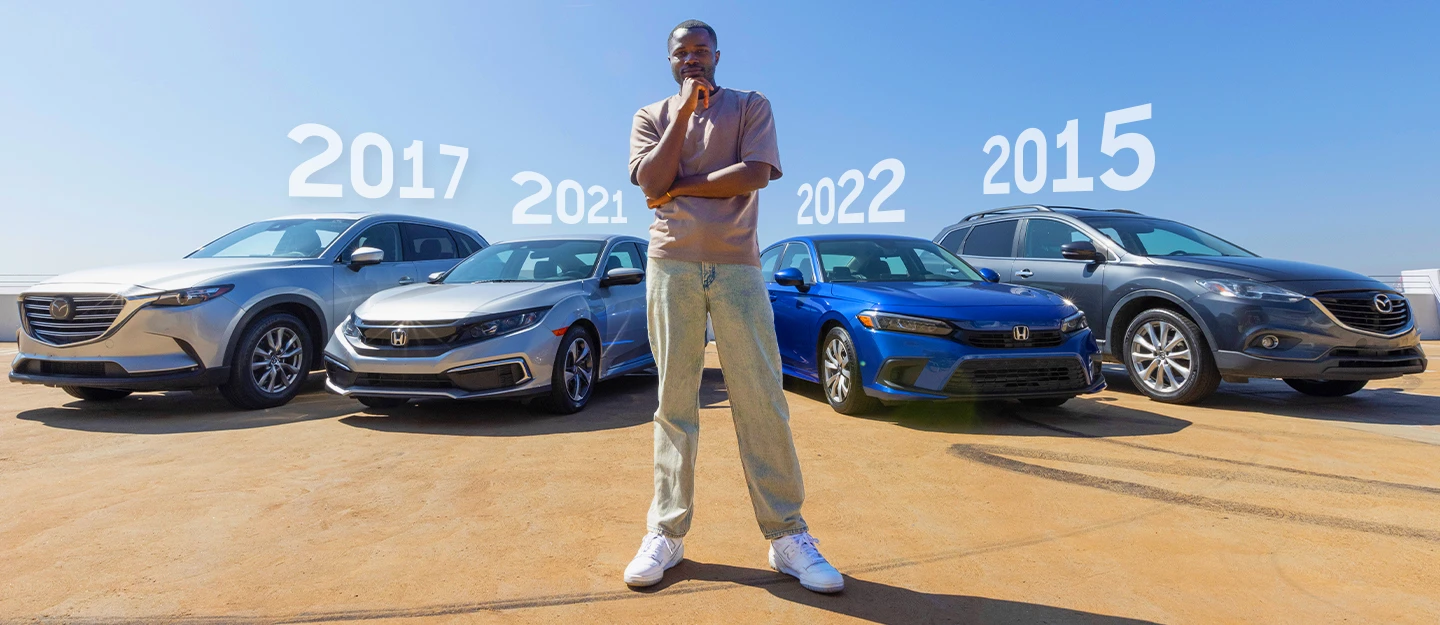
[852, 330, 1104, 402]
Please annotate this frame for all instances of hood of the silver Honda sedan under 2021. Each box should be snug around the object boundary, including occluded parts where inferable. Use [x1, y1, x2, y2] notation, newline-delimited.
[356, 281, 580, 323]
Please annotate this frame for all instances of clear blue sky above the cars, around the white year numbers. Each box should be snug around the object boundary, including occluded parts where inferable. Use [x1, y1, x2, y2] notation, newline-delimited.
[0, 0, 1440, 274]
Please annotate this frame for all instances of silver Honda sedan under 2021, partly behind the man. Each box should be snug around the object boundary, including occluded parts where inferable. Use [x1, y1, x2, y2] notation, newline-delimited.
[325, 235, 655, 413]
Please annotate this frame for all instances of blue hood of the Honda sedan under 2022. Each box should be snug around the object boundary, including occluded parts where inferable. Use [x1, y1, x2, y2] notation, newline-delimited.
[832, 282, 1066, 310]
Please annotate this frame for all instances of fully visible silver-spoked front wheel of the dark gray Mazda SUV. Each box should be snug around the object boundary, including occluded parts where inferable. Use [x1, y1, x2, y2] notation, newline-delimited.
[1122, 308, 1220, 403]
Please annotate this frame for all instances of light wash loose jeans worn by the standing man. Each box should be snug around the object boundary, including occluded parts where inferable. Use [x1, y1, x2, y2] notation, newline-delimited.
[645, 258, 806, 540]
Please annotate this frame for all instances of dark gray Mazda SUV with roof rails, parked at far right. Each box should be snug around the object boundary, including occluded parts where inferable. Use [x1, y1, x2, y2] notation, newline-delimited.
[935, 206, 1426, 403]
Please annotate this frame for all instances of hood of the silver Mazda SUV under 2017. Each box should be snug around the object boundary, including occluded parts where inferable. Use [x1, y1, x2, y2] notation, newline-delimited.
[30, 258, 315, 292]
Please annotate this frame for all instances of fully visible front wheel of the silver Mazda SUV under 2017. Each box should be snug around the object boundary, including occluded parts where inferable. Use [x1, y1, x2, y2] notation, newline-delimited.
[220, 313, 315, 410]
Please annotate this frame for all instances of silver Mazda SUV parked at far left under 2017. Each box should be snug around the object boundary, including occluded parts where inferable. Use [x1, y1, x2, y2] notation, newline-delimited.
[10, 213, 488, 409]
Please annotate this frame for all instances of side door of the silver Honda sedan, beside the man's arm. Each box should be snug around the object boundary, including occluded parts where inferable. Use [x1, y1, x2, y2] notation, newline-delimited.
[596, 240, 649, 376]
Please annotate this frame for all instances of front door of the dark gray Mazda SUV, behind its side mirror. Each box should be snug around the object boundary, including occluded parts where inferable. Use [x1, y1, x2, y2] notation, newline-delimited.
[1009, 217, 1104, 320]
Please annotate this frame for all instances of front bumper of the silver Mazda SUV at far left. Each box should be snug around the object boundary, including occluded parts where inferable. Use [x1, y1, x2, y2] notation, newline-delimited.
[9, 290, 240, 390]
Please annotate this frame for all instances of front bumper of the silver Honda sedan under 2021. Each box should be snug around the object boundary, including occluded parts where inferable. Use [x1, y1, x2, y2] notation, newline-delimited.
[325, 324, 560, 399]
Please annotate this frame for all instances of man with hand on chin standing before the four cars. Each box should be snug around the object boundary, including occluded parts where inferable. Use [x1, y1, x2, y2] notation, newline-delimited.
[625, 20, 845, 592]
